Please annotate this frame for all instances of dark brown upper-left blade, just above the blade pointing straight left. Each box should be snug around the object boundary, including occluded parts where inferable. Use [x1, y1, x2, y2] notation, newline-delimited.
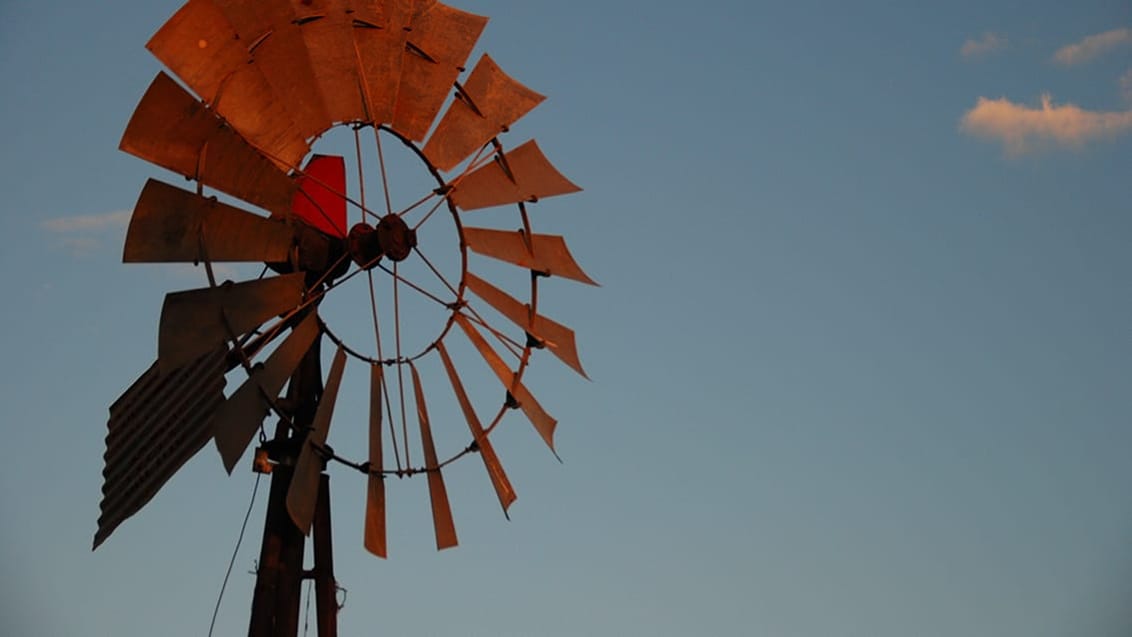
[120, 72, 295, 215]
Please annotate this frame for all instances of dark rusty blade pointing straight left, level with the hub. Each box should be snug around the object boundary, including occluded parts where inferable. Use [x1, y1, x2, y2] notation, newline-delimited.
[122, 179, 294, 264]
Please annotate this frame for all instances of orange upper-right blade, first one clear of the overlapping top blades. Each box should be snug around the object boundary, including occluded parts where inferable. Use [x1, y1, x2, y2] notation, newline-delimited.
[425, 55, 546, 171]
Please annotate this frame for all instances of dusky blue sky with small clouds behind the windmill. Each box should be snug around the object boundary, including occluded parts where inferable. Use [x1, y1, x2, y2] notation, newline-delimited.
[0, 0, 1132, 637]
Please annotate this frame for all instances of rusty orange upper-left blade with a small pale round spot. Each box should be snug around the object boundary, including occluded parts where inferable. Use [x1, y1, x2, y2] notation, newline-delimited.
[146, 0, 316, 171]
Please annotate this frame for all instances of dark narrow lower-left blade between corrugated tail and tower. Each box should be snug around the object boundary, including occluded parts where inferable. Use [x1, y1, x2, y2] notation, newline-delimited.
[212, 313, 318, 473]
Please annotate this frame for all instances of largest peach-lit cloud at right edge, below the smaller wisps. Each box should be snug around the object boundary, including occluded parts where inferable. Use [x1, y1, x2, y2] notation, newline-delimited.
[960, 95, 1132, 156]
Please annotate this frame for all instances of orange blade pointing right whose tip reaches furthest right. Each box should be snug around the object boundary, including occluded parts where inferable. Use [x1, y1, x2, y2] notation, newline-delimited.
[464, 226, 598, 285]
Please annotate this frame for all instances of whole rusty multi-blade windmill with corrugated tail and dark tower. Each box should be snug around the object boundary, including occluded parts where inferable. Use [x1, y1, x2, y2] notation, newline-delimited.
[94, 0, 594, 636]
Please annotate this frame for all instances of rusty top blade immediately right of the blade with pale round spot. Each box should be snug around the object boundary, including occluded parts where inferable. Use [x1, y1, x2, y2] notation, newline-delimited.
[212, 0, 333, 139]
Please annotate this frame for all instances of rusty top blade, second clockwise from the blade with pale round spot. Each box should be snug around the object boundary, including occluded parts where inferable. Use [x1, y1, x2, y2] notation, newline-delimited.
[291, 0, 367, 122]
